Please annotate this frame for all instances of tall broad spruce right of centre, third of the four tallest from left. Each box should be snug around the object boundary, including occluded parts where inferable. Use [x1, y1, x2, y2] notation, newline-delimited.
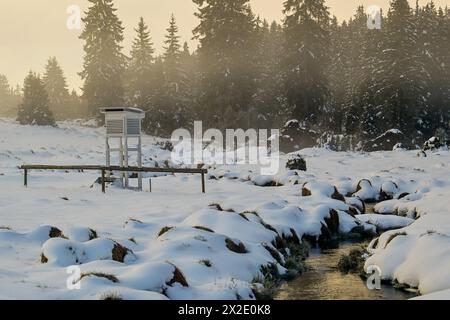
[283, 0, 330, 127]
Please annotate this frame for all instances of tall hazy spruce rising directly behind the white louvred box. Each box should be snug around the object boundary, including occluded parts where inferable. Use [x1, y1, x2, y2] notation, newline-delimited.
[80, 0, 126, 121]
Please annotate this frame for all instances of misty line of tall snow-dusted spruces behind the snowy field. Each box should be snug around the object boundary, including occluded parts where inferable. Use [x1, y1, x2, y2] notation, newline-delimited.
[10, 0, 450, 147]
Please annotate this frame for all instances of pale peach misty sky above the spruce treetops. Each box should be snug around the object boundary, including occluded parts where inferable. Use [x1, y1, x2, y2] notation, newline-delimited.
[0, 0, 450, 91]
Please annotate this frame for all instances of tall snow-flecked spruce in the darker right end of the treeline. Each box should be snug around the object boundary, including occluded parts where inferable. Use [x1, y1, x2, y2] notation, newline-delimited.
[373, 0, 429, 136]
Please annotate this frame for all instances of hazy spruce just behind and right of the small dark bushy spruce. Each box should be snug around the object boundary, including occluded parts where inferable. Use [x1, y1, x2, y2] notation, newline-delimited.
[43, 57, 73, 120]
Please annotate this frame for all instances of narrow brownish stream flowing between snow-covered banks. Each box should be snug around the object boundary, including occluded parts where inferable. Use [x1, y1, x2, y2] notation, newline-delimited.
[275, 242, 416, 300]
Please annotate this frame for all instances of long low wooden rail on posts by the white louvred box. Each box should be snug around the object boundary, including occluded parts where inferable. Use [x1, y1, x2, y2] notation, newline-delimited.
[20, 165, 208, 193]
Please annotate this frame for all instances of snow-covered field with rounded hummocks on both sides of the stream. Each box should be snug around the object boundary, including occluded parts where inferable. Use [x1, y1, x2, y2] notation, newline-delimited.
[0, 119, 450, 299]
